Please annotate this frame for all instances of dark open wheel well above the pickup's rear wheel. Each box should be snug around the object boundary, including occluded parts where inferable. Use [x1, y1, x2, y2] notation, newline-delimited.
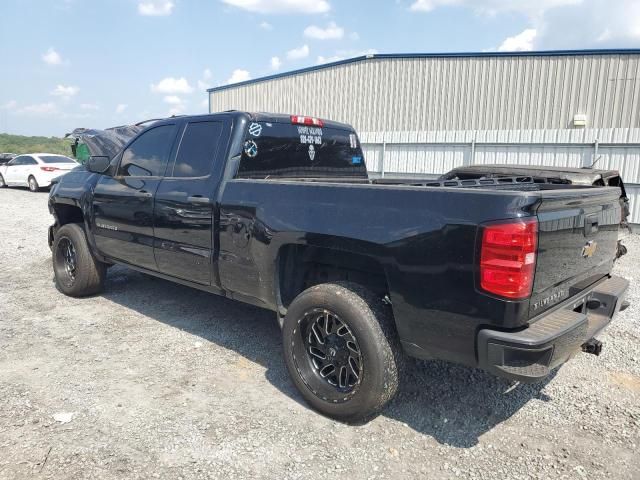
[278, 245, 389, 307]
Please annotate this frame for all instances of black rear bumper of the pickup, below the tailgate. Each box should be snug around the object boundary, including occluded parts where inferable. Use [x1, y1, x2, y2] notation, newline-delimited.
[477, 277, 629, 382]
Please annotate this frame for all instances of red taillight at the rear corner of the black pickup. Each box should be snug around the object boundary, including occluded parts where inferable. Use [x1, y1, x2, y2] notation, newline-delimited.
[480, 219, 538, 299]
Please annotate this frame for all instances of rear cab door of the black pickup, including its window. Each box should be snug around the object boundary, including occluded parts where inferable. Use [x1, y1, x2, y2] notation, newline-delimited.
[154, 117, 230, 285]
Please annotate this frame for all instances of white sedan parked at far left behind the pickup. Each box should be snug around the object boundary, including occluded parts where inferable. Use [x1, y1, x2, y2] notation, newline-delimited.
[0, 153, 78, 192]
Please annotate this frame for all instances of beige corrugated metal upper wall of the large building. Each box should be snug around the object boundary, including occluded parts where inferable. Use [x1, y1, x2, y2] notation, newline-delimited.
[210, 54, 640, 135]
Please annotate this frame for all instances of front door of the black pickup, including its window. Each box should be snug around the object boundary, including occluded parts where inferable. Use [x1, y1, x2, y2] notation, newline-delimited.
[91, 123, 177, 270]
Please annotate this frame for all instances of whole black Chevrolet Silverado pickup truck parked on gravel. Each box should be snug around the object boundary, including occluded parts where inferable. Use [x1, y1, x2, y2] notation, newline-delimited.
[49, 112, 628, 421]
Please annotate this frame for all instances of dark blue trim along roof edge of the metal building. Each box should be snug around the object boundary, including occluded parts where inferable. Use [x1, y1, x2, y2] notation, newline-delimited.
[207, 48, 640, 92]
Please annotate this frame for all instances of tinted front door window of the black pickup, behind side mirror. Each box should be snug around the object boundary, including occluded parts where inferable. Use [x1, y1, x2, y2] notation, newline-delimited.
[120, 125, 175, 177]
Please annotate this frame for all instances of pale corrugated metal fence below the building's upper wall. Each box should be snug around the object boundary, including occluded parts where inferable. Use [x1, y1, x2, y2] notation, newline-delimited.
[360, 128, 640, 185]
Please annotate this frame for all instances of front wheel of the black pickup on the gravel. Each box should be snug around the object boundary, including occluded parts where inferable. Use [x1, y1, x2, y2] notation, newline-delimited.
[53, 223, 107, 297]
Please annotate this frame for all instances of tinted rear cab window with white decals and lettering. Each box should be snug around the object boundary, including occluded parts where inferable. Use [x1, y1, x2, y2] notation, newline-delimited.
[237, 122, 367, 178]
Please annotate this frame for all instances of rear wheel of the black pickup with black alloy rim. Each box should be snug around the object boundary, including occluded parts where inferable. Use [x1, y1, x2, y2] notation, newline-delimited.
[282, 282, 404, 422]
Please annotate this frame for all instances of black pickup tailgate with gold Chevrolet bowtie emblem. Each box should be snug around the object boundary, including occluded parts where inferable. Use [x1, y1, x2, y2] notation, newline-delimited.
[529, 187, 620, 317]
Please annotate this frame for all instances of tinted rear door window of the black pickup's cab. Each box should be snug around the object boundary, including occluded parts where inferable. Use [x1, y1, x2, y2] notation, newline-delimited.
[173, 122, 222, 177]
